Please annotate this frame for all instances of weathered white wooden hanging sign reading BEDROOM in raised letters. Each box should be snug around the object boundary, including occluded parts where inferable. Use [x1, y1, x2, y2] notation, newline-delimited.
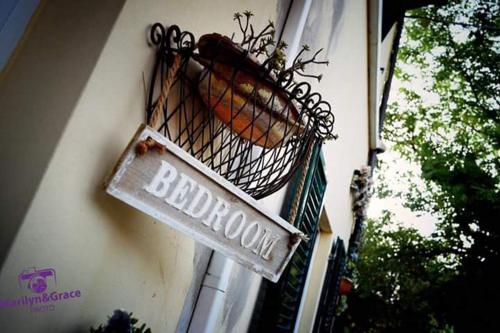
[106, 125, 303, 282]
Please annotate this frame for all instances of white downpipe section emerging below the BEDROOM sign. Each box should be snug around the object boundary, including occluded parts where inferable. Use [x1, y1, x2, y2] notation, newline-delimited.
[188, 251, 234, 333]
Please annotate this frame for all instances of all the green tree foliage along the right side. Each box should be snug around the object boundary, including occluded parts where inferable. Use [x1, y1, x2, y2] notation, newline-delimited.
[348, 0, 500, 332]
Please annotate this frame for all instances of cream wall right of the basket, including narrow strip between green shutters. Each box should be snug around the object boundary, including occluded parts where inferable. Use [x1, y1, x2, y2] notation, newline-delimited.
[298, 0, 368, 332]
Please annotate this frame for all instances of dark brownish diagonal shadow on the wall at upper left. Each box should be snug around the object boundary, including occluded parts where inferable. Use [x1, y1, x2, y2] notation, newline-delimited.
[0, 0, 125, 266]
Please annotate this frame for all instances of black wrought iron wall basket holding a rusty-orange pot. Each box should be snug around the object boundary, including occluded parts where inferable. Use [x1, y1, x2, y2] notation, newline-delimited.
[146, 23, 334, 199]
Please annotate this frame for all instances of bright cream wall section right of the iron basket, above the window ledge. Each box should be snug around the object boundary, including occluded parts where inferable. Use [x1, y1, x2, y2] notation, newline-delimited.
[319, 0, 368, 241]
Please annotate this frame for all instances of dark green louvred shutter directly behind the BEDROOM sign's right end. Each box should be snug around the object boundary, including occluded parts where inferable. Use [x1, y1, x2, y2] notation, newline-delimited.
[250, 144, 326, 332]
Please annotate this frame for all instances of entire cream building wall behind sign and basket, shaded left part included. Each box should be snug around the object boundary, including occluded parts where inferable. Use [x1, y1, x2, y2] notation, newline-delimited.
[0, 0, 376, 332]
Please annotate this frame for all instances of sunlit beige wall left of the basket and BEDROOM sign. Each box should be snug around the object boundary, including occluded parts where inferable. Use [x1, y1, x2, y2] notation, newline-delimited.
[0, 0, 276, 332]
